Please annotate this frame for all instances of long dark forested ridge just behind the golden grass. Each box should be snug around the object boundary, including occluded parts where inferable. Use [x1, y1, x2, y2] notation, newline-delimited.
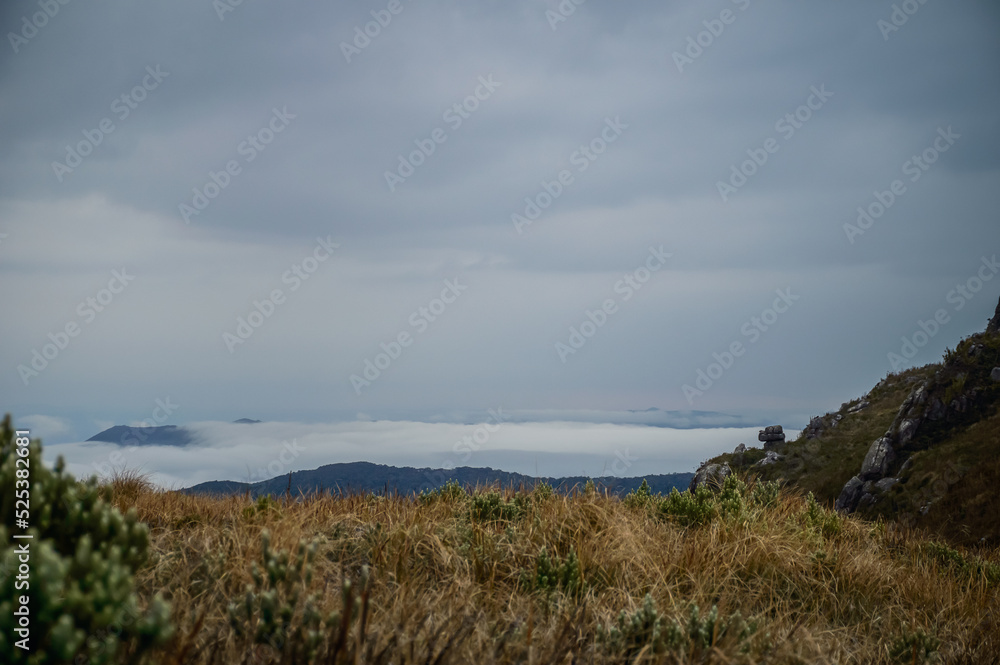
[181, 462, 694, 498]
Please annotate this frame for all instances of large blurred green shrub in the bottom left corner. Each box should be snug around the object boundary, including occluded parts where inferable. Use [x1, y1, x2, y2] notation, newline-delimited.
[0, 415, 172, 664]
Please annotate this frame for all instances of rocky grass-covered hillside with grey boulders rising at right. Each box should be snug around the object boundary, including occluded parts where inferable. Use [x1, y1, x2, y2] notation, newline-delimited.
[712, 296, 1000, 544]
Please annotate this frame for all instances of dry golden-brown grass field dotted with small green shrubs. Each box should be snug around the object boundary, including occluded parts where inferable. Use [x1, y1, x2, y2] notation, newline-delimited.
[102, 475, 1000, 665]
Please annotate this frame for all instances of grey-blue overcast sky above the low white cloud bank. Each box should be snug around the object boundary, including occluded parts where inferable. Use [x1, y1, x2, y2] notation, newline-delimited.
[0, 0, 1000, 478]
